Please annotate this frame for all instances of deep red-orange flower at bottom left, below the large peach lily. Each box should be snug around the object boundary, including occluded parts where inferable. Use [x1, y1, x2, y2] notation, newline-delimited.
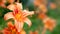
[2, 22, 26, 34]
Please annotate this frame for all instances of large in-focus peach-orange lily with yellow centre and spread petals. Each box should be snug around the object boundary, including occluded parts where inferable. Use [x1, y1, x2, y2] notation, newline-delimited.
[4, 3, 34, 32]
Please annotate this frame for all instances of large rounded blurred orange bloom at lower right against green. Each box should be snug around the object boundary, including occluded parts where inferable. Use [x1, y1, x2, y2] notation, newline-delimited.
[43, 18, 56, 31]
